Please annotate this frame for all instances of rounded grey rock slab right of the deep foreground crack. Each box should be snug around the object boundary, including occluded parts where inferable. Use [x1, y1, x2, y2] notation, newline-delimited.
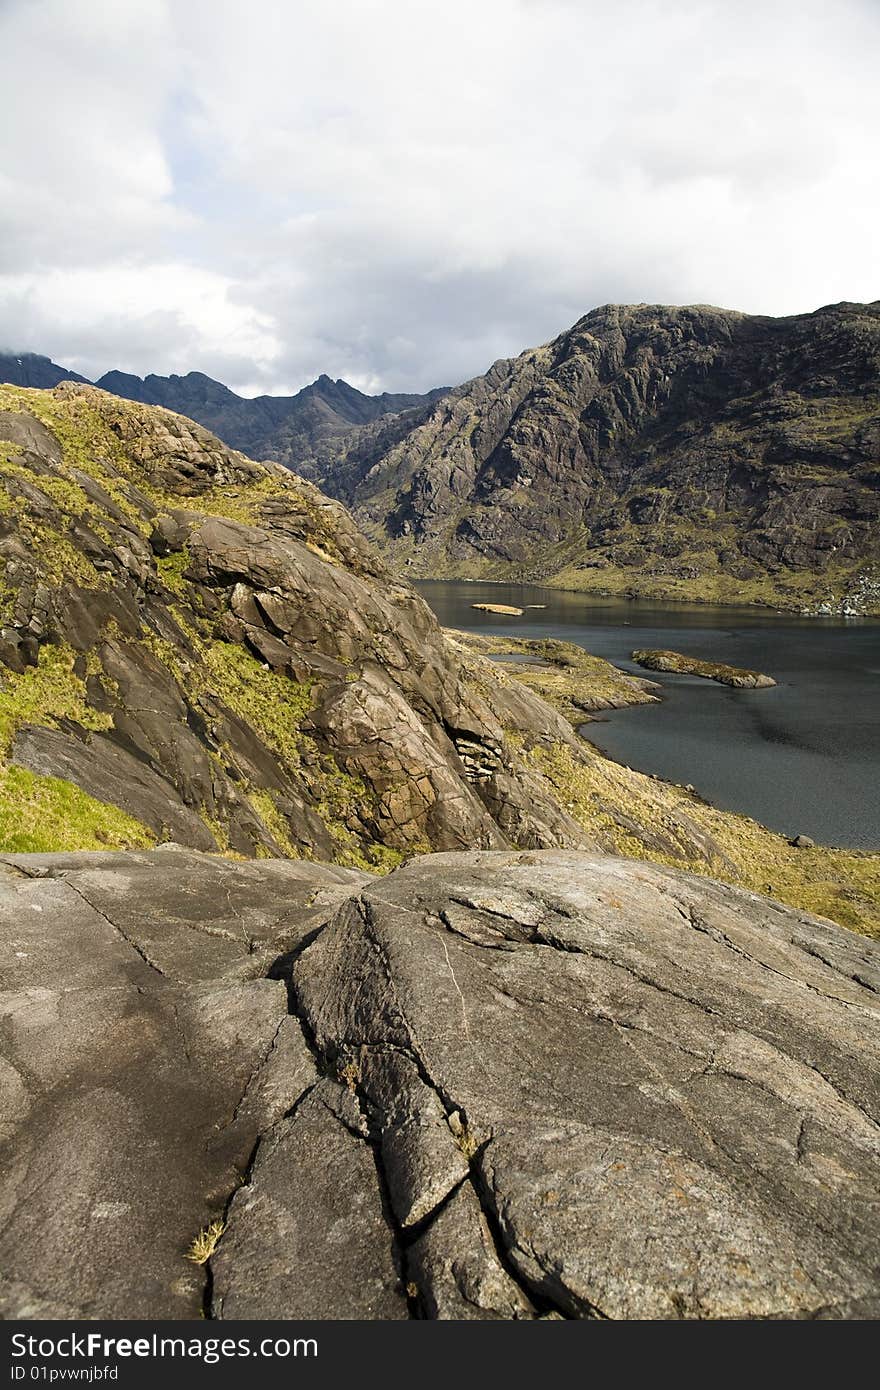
[293, 852, 880, 1318]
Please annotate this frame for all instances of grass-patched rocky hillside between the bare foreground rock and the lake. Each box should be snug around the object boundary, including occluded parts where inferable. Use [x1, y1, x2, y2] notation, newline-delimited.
[0, 385, 880, 931]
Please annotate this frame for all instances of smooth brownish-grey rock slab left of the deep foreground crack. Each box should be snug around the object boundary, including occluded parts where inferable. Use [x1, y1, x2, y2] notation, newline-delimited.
[0, 852, 364, 1318]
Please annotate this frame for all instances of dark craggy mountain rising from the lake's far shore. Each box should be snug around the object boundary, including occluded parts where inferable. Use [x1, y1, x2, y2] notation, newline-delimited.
[328, 302, 880, 612]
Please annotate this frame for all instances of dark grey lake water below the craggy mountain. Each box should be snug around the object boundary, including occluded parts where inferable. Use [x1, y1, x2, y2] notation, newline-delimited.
[418, 581, 880, 849]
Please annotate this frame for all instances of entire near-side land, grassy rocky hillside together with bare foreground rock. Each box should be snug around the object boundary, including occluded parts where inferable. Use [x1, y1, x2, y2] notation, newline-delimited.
[0, 381, 880, 1321]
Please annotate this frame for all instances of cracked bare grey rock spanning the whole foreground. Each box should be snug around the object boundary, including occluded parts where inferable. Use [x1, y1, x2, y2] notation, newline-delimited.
[0, 849, 880, 1319]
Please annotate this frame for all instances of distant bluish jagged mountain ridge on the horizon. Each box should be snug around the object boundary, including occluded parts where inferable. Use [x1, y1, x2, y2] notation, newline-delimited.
[0, 353, 443, 478]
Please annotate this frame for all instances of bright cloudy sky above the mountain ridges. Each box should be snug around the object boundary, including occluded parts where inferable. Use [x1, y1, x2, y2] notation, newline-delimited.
[0, 0, 880, 395]
